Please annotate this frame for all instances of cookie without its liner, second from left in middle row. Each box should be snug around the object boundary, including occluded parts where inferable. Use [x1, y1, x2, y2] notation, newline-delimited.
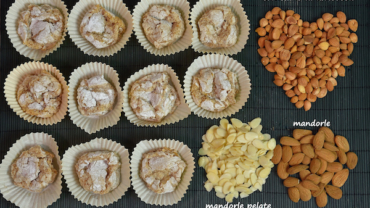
[77, 75, 117, 117]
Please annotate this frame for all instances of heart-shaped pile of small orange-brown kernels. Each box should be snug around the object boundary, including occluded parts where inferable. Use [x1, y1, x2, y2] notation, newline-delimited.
[256, 7, 358, 111]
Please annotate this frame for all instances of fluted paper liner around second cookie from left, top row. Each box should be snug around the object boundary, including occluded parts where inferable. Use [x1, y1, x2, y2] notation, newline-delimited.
[68, 0, 133, 56]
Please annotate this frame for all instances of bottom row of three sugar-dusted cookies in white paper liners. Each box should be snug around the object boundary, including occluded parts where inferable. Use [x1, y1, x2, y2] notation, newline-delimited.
[0, 133, 195, 207]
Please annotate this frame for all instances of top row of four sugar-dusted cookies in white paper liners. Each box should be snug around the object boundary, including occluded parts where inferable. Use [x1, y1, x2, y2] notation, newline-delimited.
[6, 0, 250, 60]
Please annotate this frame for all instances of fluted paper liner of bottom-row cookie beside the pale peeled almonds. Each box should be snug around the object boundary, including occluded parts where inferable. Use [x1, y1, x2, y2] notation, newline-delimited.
[131, 139, 195, 205]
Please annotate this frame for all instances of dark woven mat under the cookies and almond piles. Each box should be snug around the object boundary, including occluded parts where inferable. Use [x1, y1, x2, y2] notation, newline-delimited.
[0, 0, 370, 208]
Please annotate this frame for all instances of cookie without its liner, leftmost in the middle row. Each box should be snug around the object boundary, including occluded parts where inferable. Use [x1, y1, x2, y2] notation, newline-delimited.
[17, 70, 62, 118]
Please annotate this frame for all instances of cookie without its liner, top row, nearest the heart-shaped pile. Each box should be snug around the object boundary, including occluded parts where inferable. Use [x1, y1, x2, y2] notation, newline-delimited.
[198, 6, 239, 48]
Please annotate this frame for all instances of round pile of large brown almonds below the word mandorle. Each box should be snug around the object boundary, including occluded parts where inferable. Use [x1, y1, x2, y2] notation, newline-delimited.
[271, 127, 358, 207]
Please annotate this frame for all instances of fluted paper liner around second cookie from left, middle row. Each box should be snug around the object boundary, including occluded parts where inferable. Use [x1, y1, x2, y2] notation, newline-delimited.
[68, 62, 123, 134]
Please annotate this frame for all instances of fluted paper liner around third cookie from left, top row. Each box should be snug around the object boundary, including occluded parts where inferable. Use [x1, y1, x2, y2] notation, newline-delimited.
[133, 0, 193, 56]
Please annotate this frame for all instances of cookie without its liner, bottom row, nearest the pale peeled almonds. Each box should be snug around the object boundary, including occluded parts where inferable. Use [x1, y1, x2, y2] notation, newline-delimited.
[140, 147, 186, 194]
